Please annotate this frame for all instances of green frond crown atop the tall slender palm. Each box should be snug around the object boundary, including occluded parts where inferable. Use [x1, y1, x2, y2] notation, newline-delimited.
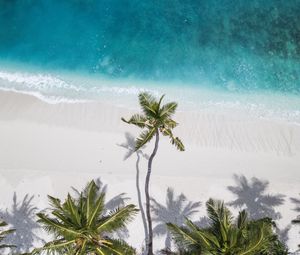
[122, 92, 184, 151]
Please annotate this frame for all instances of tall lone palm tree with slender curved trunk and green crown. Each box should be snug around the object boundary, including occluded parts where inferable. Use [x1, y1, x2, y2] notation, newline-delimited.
[122, 92, 184, 255]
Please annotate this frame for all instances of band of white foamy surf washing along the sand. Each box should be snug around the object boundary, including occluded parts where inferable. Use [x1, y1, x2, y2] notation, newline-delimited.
[0, 67, 300, 124]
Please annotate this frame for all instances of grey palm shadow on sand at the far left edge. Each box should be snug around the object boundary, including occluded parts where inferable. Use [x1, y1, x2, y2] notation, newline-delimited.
[0, 192, 44, 254]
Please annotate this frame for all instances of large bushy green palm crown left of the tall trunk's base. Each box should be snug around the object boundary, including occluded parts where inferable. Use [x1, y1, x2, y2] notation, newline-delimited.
[31, 181, 138, 255]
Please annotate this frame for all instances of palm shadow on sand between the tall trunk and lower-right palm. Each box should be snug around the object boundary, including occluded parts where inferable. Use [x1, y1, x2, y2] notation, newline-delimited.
[151, 188, 201, 249]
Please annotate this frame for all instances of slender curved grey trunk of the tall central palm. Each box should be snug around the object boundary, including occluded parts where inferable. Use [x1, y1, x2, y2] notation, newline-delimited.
[145, 130, 159, 255]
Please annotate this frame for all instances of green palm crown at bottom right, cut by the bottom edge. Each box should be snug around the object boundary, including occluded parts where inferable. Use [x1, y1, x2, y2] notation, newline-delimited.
[167, 199, 287, 255]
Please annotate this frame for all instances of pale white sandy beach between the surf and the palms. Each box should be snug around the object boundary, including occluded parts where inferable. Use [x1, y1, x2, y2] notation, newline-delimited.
[0, 91, 300, 253]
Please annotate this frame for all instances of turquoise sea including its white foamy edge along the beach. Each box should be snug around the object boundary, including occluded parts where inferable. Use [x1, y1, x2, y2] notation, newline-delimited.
[0, 0, 300, 120]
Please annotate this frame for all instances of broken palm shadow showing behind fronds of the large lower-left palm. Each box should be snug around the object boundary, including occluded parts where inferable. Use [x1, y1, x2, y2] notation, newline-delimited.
[71, 178, 130, 239]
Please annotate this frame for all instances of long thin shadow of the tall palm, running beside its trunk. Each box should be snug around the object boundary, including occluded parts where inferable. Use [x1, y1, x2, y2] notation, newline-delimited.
[118, 132, 149, 250]
